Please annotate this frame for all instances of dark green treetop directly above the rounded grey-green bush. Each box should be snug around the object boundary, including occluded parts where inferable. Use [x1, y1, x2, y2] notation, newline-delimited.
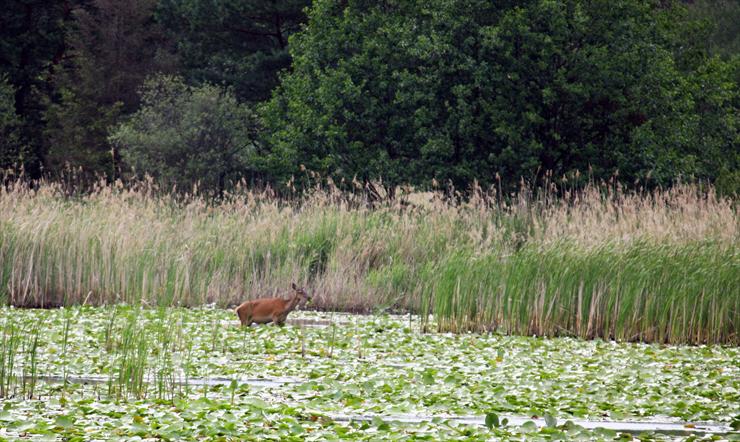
[157, 0, 310, 102]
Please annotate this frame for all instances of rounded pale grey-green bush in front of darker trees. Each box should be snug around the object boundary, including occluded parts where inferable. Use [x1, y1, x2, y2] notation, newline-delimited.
[109, 76, 257, 193]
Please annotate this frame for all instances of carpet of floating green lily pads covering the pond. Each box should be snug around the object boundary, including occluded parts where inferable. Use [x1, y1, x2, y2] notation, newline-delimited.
[0, 306, 740, 440]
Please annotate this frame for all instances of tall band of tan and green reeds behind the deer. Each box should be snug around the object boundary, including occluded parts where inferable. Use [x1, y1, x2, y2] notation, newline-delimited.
[0, 183, 740, 345]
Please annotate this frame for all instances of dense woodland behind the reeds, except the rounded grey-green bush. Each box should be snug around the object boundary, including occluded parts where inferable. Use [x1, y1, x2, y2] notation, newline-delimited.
[0, 0, 740, 193]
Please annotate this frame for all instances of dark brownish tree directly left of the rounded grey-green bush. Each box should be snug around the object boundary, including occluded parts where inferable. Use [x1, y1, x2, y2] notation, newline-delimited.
[45, 0, 175, 180]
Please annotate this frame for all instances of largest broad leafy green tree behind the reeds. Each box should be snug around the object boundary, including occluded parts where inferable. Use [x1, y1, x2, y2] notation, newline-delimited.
[264, 0, 736, 186]
